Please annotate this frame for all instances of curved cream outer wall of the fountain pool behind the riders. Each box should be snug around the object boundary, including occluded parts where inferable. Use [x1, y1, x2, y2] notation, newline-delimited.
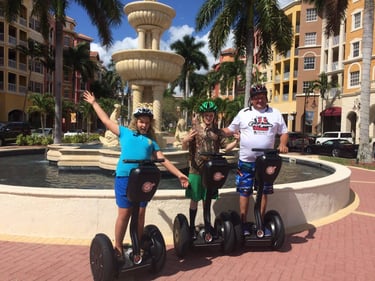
[0, 153, 351, 244]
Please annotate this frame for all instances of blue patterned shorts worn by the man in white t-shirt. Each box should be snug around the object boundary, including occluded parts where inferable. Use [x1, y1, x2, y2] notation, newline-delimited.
[236, 160, 273, 197]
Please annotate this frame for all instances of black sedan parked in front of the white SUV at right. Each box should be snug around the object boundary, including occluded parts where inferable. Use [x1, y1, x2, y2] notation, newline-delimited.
[305, 139, 359, 158]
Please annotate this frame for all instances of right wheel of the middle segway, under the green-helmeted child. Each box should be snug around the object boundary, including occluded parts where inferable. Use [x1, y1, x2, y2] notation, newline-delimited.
[215, 212, 236, 254]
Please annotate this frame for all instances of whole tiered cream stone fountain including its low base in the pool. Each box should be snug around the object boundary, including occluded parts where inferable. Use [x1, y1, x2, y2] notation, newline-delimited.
[47, 0, 191, 171]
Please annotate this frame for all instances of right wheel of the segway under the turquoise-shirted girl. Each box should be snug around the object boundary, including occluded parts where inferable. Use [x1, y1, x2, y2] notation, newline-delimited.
[142, 224, 167, 273]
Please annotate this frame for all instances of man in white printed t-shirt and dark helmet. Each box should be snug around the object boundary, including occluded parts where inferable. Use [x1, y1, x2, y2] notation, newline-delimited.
[222, 85, 288, 236]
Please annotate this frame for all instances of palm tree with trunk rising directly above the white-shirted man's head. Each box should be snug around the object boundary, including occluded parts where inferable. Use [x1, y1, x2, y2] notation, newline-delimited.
[196, 0, 293, 104]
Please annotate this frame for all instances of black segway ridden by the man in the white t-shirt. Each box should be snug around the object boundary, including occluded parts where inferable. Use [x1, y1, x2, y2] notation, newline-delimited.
[230, 148, 285, 250]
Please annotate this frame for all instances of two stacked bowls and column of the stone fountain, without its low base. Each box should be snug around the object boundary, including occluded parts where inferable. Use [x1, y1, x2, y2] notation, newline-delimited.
[112, 0, 184, 146]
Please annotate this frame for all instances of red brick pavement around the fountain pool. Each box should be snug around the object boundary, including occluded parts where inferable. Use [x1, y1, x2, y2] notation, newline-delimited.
[0, 165, 375, 281]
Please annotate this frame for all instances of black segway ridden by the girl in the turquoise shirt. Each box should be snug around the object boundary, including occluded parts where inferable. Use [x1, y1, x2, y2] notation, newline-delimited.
[90, 159, 166, 281]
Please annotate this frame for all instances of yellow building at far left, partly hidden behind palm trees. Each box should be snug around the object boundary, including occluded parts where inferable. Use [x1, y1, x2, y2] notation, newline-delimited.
[0, 0, 95, 129]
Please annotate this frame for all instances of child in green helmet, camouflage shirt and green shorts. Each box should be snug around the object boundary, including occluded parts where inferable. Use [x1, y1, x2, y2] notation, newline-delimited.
[182, 101, 238, 239]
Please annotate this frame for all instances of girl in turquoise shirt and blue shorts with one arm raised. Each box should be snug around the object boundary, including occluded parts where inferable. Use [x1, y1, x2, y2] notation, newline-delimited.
[83, 91, 189, 263]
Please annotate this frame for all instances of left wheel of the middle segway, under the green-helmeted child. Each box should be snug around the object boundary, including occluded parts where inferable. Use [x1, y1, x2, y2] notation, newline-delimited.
[173, 214, 190, 259]
